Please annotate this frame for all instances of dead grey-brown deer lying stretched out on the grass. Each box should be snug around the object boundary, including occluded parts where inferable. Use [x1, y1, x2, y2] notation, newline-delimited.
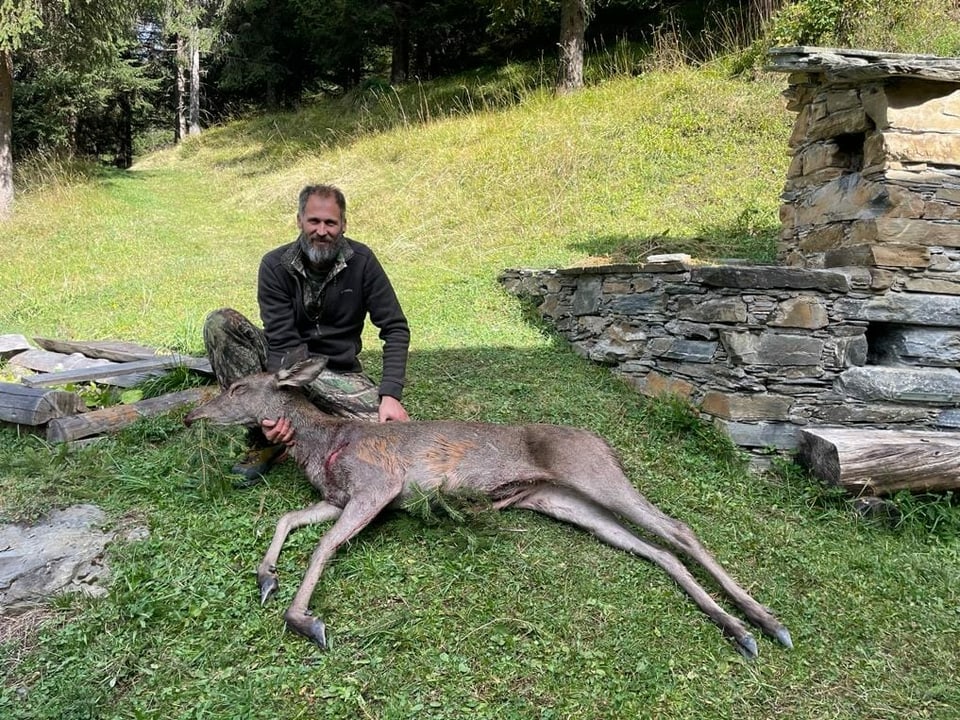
[185, 358, 792, 658]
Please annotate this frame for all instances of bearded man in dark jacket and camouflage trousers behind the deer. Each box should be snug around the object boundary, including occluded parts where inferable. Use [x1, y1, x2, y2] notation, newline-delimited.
[203, 185, 410, 487]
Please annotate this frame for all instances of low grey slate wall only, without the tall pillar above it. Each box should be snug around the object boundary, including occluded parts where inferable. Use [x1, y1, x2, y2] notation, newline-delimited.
[500, 260, 960, 450]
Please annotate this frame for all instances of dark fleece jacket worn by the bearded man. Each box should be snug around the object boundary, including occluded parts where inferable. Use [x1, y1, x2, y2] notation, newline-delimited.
[257, 239, 410, 400]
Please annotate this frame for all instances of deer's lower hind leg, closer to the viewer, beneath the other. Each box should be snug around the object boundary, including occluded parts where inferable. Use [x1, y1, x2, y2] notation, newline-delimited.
[513, 485, 757, 658]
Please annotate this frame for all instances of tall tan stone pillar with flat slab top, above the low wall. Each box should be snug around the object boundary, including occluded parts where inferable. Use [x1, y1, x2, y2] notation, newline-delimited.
[770, 43, 960, 294]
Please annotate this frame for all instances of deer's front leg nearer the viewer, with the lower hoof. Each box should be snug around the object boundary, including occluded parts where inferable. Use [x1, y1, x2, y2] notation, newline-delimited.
[283, 488, 399, 649]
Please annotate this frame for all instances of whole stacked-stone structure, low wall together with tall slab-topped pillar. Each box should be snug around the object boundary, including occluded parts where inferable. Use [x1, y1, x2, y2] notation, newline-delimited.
[501, 48, 960, 450]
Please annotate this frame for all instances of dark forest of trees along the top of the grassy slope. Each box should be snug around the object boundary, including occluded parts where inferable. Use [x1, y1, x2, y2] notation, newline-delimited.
[7, 0, 960, 180]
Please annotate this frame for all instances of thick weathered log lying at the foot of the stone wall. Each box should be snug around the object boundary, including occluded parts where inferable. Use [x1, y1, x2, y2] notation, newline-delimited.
[797, 428, 960, 495]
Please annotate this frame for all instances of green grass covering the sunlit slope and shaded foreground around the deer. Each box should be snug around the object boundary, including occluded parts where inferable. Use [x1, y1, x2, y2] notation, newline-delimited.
[0, 64, 960, 720]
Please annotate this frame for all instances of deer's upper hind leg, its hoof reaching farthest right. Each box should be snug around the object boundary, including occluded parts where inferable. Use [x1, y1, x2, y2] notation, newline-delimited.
[576, 471, 793, 648]
